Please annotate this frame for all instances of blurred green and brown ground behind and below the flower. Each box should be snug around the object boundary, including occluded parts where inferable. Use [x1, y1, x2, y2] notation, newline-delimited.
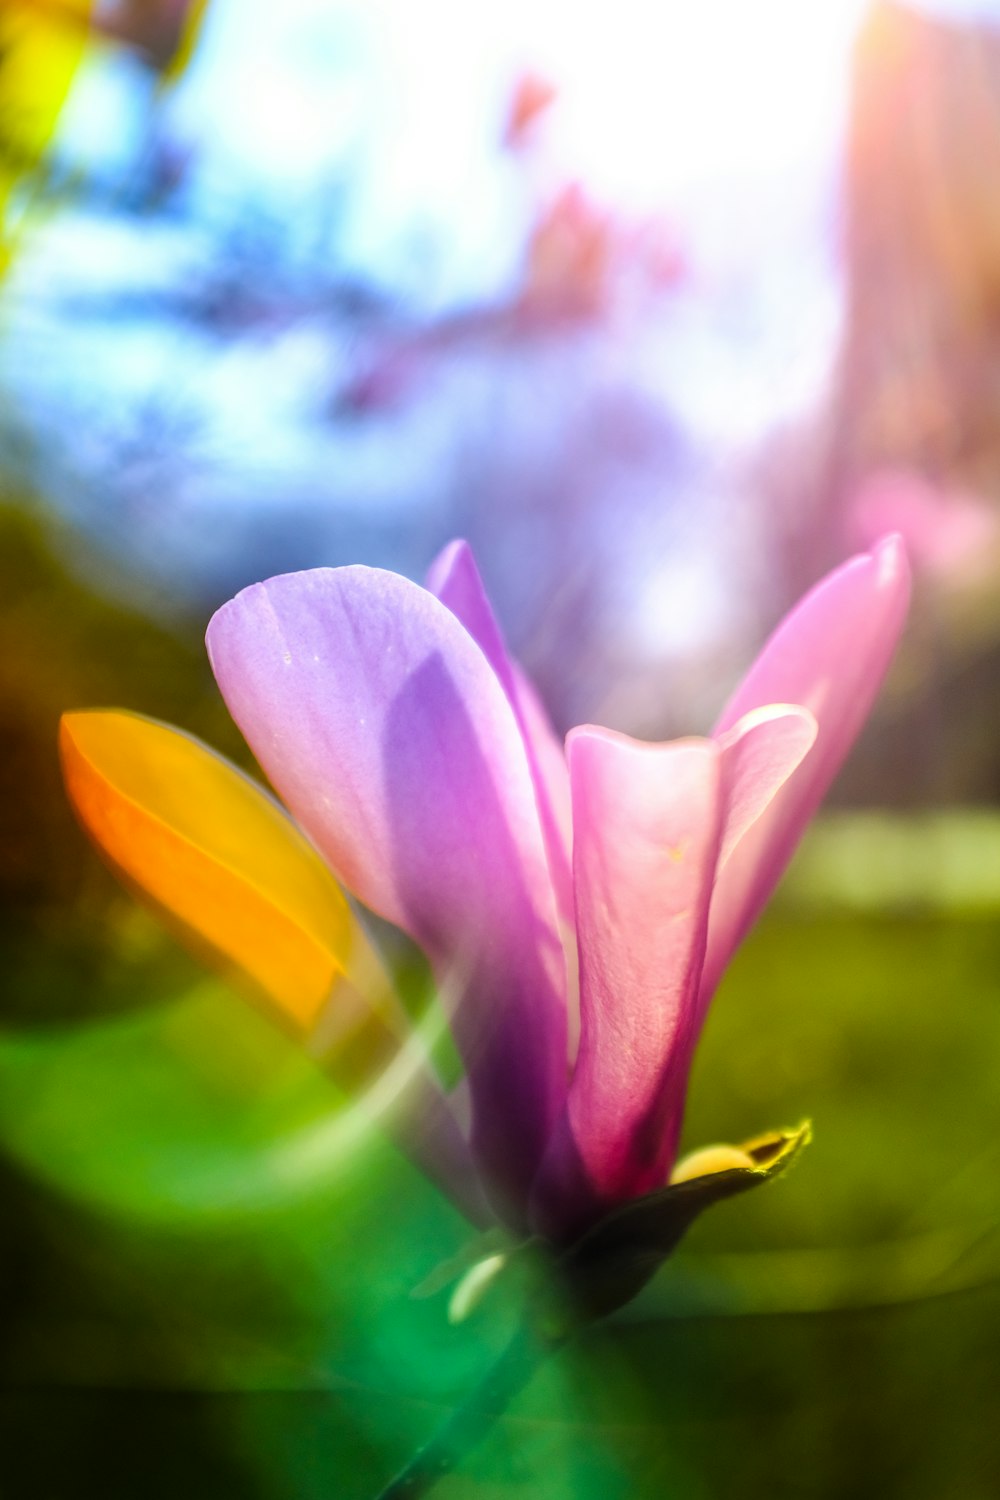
[0, 501, 1000, 1500]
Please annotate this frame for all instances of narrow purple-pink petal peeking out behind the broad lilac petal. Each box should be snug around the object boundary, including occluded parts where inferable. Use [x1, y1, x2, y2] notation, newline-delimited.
[427, 542, 573, 926]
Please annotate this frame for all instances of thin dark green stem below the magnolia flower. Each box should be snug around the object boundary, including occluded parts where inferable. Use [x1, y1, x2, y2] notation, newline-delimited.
[376, 1325, 567, 1500]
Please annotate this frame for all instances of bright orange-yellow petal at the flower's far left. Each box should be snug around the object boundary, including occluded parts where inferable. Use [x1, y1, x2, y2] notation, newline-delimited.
[60, 711, 370, 1028]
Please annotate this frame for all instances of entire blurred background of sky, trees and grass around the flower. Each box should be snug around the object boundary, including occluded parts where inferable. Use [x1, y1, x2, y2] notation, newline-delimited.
[0, 0, 1000, 1500]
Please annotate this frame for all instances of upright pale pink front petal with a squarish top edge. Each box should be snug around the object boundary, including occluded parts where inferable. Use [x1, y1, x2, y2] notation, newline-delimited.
[534, 726, 724, 1235]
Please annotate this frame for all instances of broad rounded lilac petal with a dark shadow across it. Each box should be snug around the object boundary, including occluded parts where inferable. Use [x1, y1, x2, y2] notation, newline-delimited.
[208, 567, 565, 1221]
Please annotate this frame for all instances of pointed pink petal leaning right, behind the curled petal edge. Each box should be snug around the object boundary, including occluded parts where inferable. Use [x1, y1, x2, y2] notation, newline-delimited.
[703, 537, 910, 995]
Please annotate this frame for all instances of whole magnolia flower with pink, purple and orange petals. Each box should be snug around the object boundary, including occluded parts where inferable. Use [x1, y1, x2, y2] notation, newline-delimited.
[61, 539, 909, 1272]
